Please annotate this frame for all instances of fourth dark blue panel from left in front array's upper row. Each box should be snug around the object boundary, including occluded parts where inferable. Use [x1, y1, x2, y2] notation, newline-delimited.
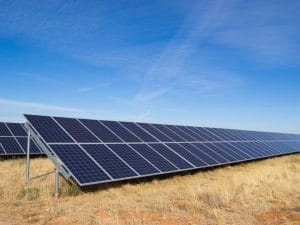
[101, 121, 141, 142]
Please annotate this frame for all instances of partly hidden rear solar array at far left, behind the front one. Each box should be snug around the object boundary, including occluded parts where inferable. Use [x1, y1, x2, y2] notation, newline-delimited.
[0, 123, 43, 156]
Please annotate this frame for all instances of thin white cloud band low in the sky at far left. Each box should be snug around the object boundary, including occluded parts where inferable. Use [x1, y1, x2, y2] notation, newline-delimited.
[0, 98, 82, 113]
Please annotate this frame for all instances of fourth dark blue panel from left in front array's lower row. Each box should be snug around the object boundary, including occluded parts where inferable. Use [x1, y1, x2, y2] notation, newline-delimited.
[130, 144, 177, 172]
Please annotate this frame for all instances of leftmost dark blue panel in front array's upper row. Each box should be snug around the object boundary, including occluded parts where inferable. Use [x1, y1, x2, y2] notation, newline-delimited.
[25, 115, 73, 143]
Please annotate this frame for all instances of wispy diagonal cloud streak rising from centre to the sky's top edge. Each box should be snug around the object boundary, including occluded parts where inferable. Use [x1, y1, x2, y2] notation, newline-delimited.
[134, 1, 239, 101]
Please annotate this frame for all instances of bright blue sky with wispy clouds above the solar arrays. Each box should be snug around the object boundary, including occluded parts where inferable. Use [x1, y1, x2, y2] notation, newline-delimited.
[0, 0, 300, 133]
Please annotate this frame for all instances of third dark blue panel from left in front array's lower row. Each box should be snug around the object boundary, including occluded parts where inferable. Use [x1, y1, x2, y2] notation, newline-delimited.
[108, 144, 159, 175]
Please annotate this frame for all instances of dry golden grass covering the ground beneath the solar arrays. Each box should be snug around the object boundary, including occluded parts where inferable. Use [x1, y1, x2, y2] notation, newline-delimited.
[0, 154, 300, 225]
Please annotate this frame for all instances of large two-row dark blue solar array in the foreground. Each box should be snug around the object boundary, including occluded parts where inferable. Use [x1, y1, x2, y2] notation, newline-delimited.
[25, 115, 300, 186]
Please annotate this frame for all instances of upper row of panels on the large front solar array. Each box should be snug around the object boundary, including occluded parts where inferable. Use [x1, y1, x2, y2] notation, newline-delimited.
[26, 115, 300, 143]
